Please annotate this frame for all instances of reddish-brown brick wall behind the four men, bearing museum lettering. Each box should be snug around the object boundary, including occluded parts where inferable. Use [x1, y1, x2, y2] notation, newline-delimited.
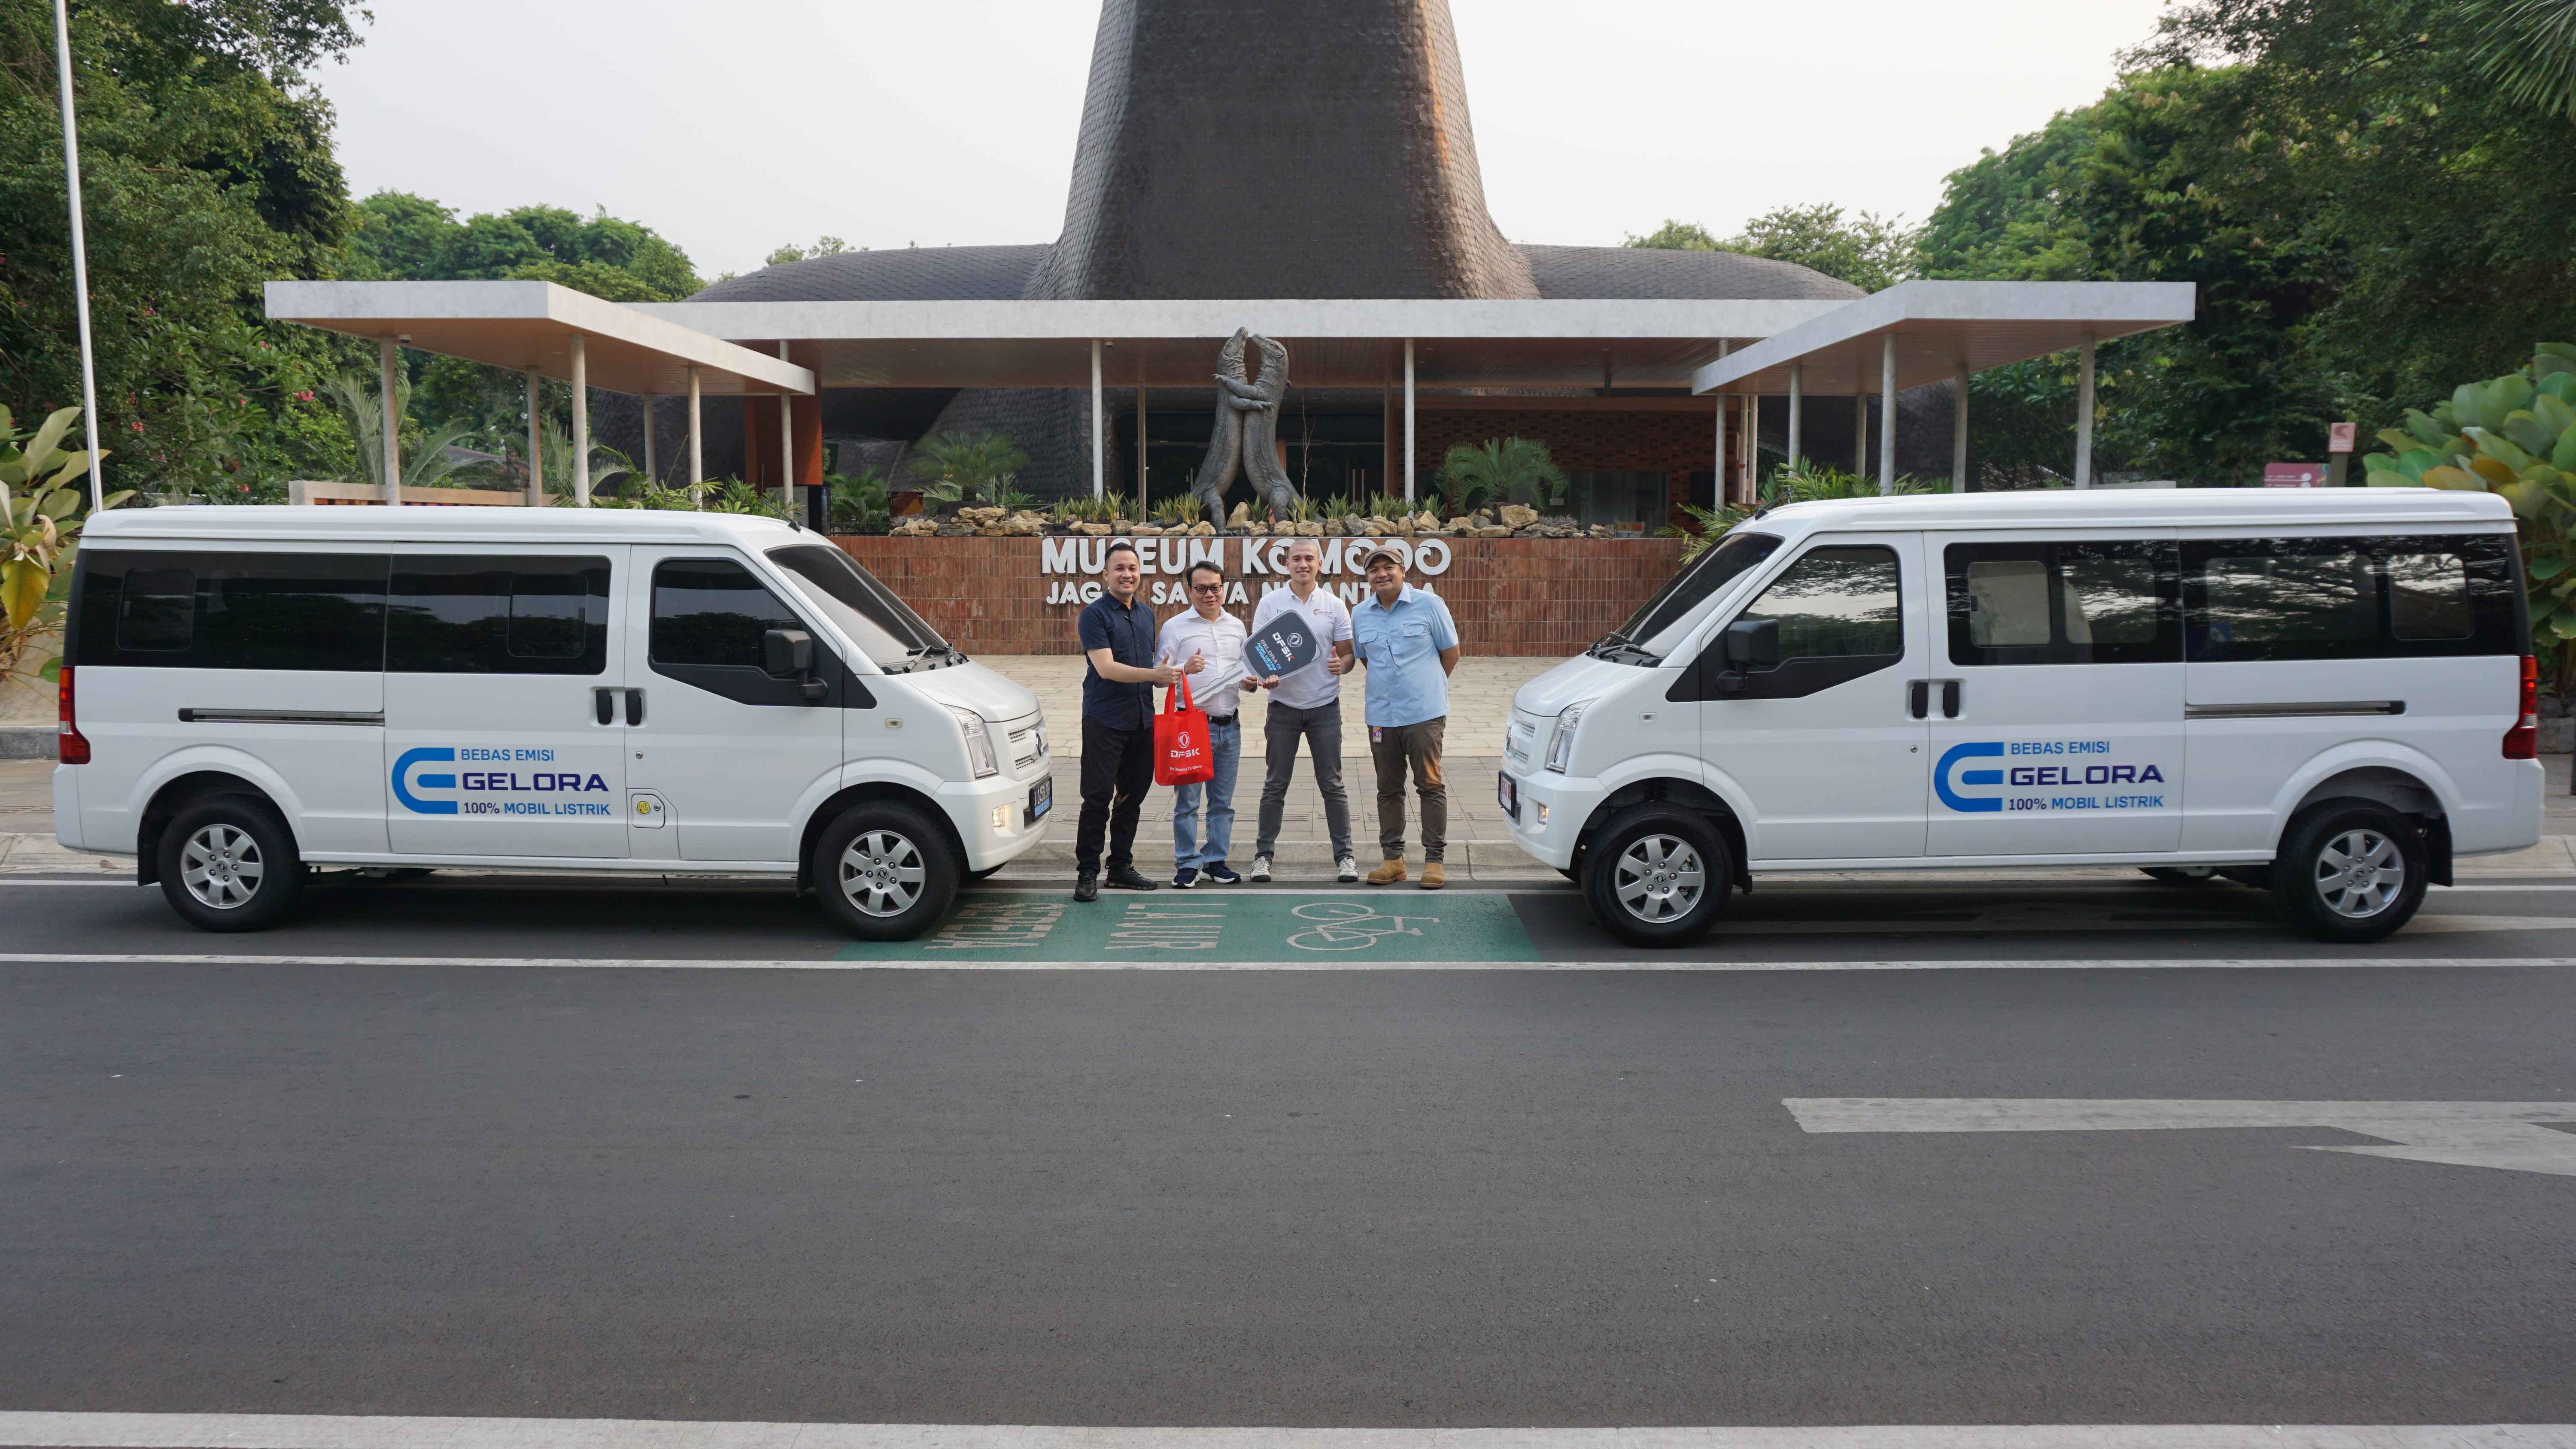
[835, 538, 1682, 656]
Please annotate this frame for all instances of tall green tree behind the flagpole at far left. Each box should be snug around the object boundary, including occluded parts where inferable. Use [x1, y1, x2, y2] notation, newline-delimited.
[0, 0, 355, 497]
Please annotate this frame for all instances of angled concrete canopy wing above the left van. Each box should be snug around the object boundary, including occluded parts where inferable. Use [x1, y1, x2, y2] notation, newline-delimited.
[268, 281, 814, 396]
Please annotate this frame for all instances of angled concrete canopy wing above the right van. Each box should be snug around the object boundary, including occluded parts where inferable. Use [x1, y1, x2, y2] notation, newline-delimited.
[1690, 281, 2195, 396]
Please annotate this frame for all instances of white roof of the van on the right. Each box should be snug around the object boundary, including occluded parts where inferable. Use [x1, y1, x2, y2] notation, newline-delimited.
[1765, 486, 2514, 533]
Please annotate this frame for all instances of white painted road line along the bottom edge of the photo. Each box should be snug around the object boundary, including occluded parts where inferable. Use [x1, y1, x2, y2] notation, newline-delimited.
[0, 1413, 2576, 1449]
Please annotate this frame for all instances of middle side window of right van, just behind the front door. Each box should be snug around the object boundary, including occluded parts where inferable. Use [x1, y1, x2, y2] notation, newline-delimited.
[1942, 540, 2182, 667]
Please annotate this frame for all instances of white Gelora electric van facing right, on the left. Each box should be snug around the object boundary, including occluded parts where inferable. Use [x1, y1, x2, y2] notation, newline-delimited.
[54, 507, 1054, 940]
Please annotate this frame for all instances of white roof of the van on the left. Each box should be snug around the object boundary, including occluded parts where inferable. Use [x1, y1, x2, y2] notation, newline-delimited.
[82, 504, 822, 548]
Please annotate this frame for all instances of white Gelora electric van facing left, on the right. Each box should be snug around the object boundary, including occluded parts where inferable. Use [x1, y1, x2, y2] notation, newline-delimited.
[1497, 489, 2543, 945]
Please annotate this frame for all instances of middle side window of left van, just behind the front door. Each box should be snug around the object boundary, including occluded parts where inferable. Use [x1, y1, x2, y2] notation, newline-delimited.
[384, 553, 608, 674]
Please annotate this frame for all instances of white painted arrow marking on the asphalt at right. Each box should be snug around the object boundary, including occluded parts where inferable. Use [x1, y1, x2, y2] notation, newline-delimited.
[1780, 1096, 2576, 1176]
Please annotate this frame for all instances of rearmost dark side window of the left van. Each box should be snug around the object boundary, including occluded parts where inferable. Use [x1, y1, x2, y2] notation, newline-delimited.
[72, 548, 389, 672]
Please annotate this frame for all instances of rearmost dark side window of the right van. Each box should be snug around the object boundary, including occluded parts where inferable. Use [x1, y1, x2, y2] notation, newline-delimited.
[2182, 533, 2530, 664]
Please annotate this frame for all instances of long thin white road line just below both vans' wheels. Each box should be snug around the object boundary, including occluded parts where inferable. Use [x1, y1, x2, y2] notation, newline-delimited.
[0, 952, 2576, 973]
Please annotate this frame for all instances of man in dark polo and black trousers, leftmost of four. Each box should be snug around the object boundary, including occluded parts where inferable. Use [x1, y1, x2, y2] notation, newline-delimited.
[1074, 538, 1203, 901]
